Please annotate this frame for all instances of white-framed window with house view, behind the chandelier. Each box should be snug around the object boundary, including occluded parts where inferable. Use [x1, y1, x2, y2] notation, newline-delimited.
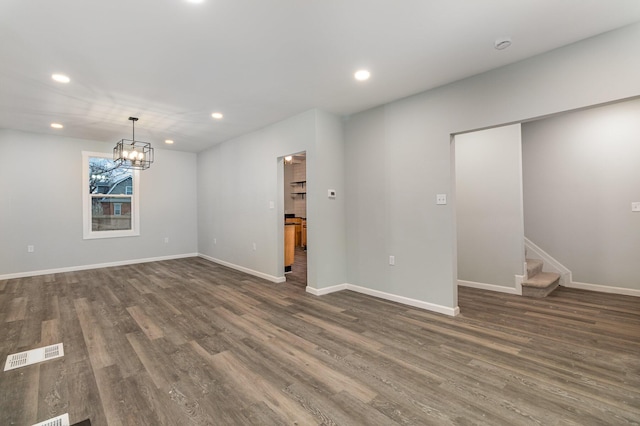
[82, 152, 140, 239]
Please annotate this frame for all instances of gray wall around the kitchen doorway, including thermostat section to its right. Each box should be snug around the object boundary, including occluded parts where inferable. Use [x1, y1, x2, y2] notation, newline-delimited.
[198, 110, 346, 288]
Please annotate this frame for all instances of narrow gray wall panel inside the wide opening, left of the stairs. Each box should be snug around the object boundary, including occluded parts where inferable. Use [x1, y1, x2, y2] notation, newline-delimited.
[455, 124, 524, 288]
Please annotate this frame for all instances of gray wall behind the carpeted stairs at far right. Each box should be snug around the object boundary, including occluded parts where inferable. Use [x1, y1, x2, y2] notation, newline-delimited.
[522, 100, 640, 289]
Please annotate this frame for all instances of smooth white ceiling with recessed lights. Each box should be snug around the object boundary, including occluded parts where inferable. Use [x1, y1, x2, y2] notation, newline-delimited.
[0, 0, 640, 152]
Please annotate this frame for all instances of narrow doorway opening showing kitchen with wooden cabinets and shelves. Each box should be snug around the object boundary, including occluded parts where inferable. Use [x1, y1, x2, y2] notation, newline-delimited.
[283, 152, 307, 287]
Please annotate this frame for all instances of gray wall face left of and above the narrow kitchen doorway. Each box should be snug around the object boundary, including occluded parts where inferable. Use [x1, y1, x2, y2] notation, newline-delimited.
[198, 111, 315, 278]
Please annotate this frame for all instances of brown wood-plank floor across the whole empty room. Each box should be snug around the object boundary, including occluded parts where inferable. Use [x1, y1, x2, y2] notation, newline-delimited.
[0, 258, 640, 426]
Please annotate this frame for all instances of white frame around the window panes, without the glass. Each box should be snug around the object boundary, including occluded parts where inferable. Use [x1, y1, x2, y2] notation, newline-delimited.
[82, 151, 140, 240]
